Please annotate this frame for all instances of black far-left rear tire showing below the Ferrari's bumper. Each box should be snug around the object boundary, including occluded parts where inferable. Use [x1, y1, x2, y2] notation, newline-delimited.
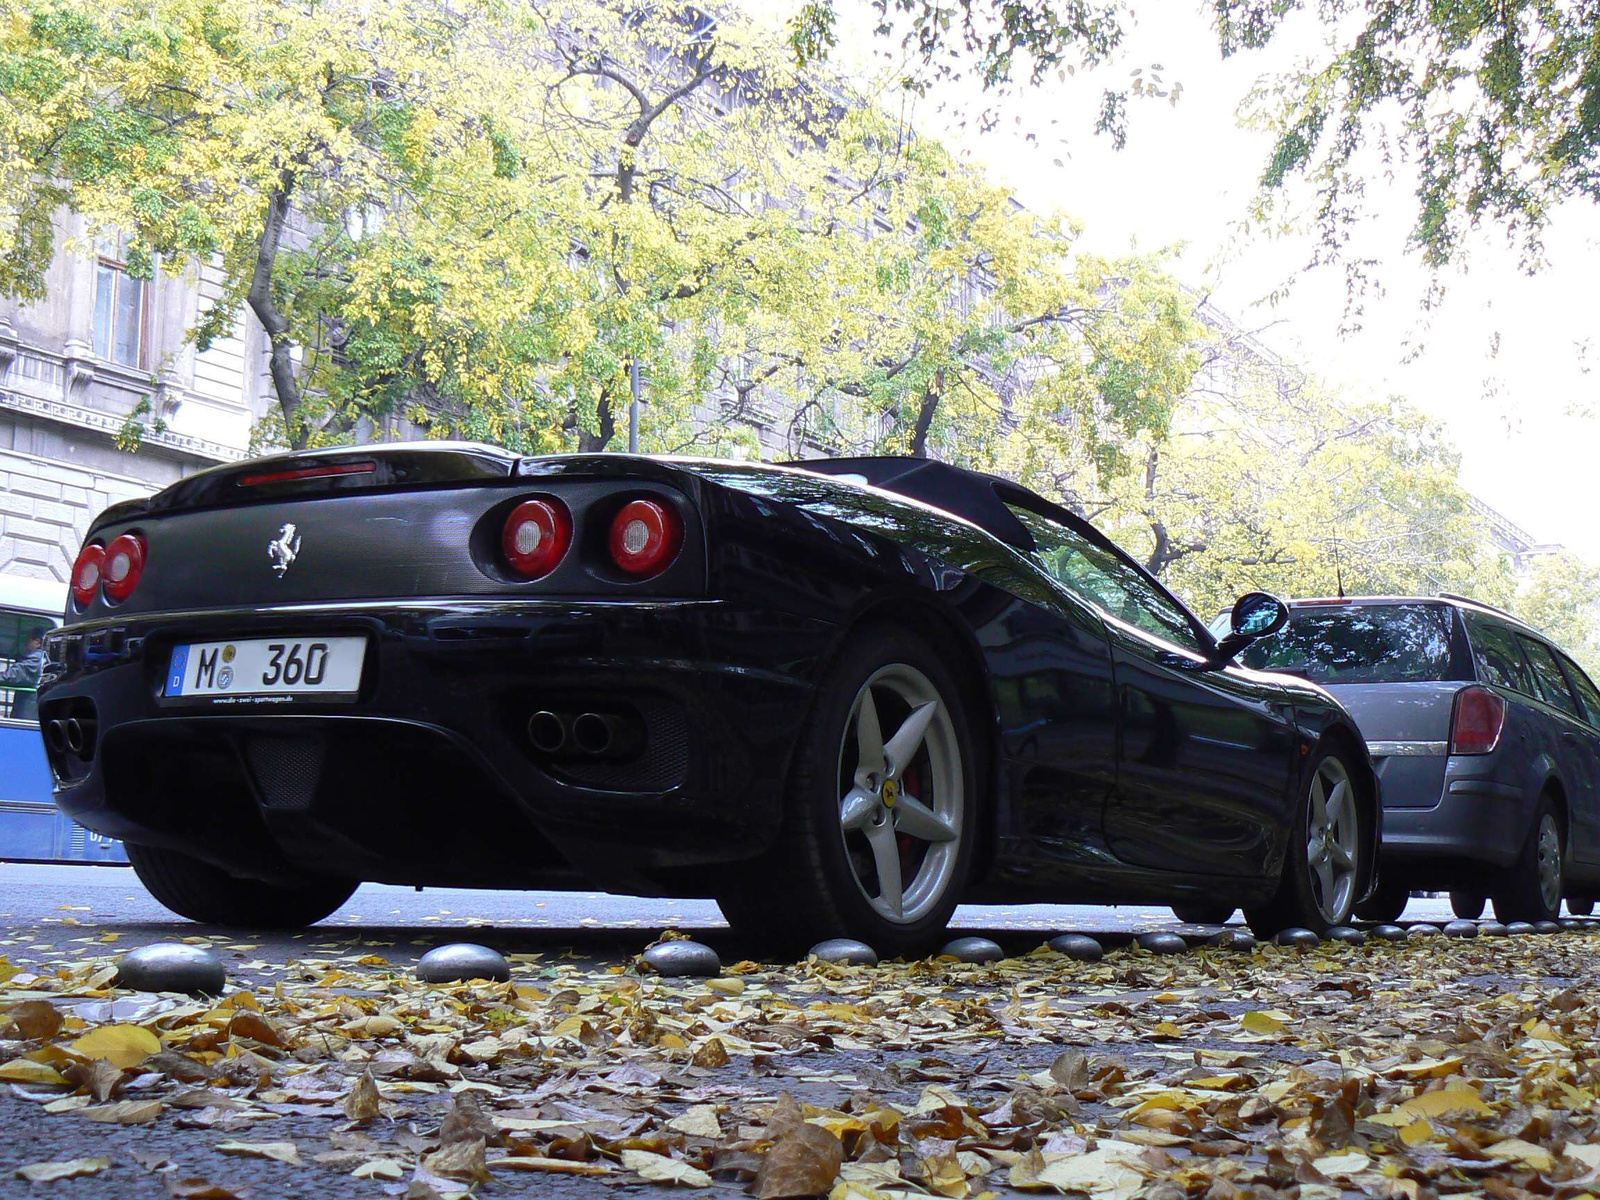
[126, 842, 357, 930]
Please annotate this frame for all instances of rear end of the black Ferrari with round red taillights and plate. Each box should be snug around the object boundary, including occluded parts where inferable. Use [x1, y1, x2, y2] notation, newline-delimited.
[40, 445, 840, 894]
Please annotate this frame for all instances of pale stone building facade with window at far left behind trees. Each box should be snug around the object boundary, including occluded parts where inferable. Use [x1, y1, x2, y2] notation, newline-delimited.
[0, 218, 259, 598]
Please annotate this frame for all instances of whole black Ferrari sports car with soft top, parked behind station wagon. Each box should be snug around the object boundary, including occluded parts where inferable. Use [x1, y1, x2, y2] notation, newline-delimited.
[40, 443, 1379, 952]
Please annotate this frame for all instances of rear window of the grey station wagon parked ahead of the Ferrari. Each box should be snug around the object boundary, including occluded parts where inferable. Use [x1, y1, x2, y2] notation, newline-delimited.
[1240, 603, 1470, 683]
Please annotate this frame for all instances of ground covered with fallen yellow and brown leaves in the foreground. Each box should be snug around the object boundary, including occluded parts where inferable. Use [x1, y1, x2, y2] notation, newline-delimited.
[0, 930, 1600, 1200]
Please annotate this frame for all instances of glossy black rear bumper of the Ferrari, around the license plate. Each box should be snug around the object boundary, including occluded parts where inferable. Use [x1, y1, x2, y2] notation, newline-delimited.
[40, 600, 834, 893]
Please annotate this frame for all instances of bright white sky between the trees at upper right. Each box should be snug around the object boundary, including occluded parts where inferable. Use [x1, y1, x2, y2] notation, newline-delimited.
[746, 0, 1600, 562]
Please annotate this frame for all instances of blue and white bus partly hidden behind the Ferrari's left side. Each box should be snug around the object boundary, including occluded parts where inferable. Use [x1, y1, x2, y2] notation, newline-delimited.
[0, 574, 128, 864]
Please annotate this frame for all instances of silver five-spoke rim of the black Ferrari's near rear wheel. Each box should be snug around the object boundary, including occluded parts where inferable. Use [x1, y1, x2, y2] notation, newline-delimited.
[838, 662, 965, 925]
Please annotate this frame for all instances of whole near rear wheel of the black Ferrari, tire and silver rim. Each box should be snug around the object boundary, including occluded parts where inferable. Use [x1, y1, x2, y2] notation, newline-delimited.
[717, 626, 982, 958]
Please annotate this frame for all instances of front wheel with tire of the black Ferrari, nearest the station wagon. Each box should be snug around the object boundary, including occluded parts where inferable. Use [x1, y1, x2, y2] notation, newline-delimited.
[1245, 750, 1366, 938]
